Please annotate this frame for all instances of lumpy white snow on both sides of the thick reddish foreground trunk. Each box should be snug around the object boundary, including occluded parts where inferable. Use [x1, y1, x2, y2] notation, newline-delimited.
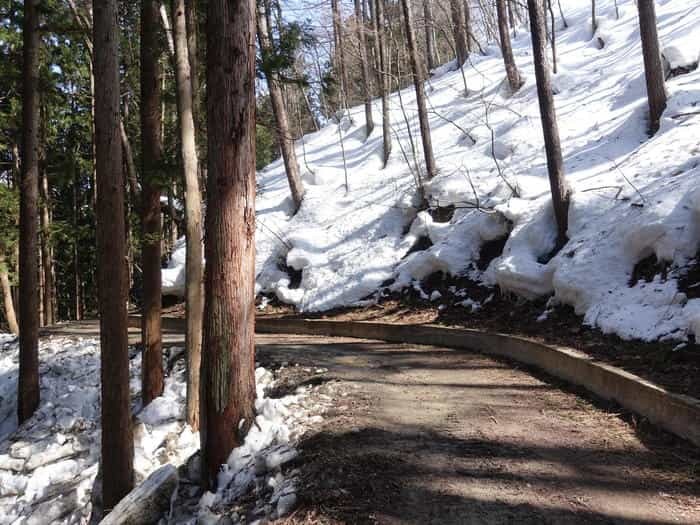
[0, 334, 317, 525]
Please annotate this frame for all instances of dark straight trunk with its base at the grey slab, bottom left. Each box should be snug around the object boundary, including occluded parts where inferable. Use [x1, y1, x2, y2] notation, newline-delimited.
[93, 0, 134, 509]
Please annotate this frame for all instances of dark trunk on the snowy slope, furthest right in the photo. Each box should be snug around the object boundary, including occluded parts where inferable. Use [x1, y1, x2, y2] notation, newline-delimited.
[637, 0, 666, 133]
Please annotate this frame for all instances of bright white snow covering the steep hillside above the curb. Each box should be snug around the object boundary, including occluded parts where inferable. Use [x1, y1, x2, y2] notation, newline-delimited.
[170, 0, 700, 340]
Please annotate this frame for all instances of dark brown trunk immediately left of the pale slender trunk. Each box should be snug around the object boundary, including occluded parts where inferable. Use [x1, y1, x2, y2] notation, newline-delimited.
[141, 0, 164, 406]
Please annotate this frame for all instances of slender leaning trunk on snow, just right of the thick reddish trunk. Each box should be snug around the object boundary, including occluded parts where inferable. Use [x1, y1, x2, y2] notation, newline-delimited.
[256, 0, 304, 213]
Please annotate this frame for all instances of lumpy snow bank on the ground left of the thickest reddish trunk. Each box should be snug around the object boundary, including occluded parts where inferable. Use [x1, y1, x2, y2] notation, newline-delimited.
[0, 337, 199, 523]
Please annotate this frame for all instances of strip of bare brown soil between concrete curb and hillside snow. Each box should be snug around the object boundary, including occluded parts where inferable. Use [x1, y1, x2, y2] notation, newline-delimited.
[258, 267, 700, 398]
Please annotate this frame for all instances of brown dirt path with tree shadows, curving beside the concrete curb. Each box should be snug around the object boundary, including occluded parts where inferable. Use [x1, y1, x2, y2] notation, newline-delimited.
[258, 336, 700, 524]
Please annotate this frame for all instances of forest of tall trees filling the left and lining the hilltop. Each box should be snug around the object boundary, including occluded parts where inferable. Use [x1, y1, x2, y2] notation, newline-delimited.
[0, 0, 666, 508]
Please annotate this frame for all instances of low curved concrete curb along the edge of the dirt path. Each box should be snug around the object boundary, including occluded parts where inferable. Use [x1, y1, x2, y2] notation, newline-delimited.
[255, 318, 700, 446]
